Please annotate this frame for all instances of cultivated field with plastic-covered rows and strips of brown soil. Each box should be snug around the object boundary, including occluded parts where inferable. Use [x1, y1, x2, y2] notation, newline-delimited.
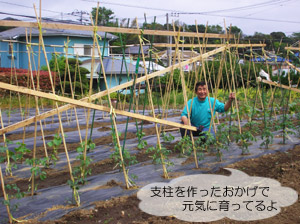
[0, 100, 299, 223]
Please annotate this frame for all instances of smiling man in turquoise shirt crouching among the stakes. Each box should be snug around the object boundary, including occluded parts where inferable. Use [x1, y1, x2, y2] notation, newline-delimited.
[180, 81, 235, 137]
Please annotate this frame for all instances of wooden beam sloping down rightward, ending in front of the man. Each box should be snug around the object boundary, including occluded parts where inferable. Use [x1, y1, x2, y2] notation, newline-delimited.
[0, 82, 197, 131]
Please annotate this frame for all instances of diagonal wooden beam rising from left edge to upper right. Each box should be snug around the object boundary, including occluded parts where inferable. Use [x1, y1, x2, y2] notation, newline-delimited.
[0, 47, 226, 134]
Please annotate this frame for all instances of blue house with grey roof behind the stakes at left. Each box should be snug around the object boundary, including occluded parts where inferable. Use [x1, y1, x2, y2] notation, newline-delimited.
[0, 27, 117, 70]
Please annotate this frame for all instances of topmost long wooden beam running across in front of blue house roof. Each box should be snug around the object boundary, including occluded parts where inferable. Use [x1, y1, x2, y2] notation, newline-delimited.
[0, 20, 234, 38]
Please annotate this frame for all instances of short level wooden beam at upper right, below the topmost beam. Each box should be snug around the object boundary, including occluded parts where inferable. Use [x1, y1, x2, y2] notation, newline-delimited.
[152, 43, 266, 48]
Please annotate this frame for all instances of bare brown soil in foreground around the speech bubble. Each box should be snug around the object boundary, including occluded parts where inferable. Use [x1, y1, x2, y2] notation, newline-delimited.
[30, 145, 300, 224]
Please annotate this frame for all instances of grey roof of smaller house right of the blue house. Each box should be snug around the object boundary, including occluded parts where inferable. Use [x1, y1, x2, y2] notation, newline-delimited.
[96, 57, 145, 74]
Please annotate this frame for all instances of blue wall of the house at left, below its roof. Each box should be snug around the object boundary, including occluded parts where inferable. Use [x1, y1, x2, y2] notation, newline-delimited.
[0, 36, 109, 70]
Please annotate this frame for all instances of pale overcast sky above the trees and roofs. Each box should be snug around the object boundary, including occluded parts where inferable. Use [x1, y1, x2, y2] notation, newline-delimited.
[0, 0, 300, 36]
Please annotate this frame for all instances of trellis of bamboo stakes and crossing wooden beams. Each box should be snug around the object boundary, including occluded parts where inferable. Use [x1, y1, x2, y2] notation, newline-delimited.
[0, 14, 292, 222]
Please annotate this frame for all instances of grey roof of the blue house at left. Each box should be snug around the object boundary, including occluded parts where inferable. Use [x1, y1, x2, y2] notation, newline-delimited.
[0, 27, 117, 40]
